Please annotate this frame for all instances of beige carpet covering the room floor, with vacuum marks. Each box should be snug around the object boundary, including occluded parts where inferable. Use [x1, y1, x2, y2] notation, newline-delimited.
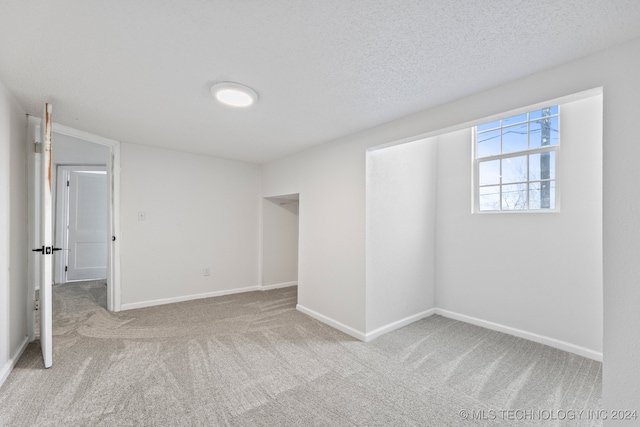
[0, 282, 602, 426]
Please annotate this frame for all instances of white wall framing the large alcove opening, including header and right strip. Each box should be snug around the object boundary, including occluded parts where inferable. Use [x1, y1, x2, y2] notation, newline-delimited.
[263, 40, 640, 409]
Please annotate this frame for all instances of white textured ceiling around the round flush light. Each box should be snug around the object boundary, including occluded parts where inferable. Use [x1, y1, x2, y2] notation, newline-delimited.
[0, 0, 640, 163]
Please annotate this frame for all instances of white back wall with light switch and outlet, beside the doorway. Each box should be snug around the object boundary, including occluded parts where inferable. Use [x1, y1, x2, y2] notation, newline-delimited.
[120, 143, 260, 309]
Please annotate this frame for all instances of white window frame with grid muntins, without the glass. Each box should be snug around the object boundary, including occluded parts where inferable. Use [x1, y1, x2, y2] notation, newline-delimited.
[471, 105, 562, 215]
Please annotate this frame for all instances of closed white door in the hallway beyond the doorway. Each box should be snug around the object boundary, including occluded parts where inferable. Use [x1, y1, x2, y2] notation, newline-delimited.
[67, 167, 108, 280]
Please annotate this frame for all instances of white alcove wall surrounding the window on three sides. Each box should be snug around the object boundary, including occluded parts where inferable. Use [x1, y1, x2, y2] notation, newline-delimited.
[436, 96, 603, 358]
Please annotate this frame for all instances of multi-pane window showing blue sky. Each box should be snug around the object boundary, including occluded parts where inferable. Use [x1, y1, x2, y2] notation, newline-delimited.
[473, 106, 560, 212]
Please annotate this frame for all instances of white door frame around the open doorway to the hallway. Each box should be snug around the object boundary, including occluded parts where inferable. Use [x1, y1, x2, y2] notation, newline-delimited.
[27, 116, 121, 341]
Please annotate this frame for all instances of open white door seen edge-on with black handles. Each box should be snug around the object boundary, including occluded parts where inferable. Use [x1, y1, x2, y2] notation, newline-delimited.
[34, 104, 54, 368]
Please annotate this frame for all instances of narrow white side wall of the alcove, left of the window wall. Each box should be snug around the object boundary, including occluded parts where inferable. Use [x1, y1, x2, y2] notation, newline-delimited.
[366, 138, 437, 339]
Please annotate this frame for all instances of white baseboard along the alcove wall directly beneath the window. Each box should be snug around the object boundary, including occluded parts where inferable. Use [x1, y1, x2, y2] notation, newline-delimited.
[435, 308, 602, 362]
